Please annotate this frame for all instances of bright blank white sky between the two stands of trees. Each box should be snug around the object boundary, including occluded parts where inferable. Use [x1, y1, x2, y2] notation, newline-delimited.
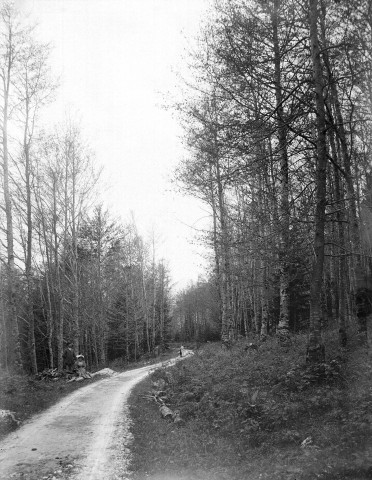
[18, 0, 210, 289]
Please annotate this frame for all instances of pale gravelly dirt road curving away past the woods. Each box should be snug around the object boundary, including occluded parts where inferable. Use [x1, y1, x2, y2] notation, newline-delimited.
[0, 365, 158, 480]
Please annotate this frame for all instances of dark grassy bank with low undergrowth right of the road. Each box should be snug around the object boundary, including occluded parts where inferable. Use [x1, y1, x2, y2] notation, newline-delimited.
[130, 332, 372, 480]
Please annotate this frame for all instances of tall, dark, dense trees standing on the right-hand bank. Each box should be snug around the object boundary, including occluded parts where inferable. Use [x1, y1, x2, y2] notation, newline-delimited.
[175, 0, 372, 361]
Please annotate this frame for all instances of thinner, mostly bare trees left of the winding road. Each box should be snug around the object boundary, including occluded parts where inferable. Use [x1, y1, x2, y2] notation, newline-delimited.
[0, 3, 170, 373]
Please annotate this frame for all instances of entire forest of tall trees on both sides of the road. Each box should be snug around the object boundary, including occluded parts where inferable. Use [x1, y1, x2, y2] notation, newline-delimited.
[0, 0, 372, 373]
